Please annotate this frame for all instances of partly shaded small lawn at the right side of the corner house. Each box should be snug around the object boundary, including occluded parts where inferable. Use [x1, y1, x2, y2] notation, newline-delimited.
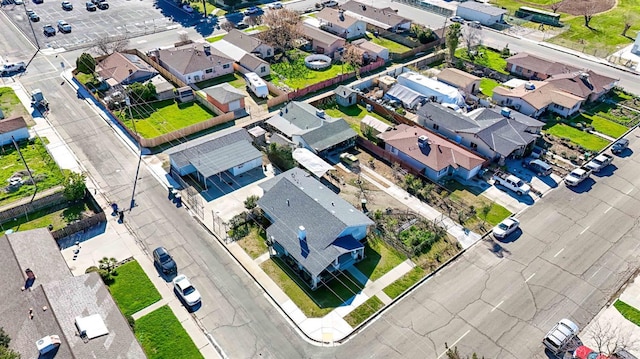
[355, 236, 407, 280]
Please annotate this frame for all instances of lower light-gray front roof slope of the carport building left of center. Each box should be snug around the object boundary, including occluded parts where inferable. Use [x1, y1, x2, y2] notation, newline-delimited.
[189, 141, 262, 178]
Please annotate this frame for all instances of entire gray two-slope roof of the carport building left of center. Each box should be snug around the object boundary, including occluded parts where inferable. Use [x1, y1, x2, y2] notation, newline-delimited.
[166, 128, 262, 177]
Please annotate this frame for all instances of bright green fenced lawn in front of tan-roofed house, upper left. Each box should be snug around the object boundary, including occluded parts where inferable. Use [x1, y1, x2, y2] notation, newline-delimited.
[116, 100, 215, 138]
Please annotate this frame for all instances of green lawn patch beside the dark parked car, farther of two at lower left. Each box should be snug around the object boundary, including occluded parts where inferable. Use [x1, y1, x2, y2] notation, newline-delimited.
[109, 261, 162, 315]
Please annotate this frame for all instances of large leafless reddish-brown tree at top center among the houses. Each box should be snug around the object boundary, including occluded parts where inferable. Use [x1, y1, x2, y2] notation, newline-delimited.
[258, 9, 302, 52]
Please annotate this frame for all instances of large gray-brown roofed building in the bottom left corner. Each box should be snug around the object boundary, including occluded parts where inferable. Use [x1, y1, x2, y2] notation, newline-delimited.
[0, 228, 146, 359]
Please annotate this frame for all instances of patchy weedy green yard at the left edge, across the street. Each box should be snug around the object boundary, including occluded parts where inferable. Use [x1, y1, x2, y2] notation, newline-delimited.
[0, 138, 64, 205]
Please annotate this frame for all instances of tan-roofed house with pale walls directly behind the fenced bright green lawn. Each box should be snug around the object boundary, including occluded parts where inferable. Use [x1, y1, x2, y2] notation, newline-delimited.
[151, 44, 234, 84]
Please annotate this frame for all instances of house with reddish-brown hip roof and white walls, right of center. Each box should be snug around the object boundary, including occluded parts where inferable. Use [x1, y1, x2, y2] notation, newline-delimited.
[378, 124, 485, 181]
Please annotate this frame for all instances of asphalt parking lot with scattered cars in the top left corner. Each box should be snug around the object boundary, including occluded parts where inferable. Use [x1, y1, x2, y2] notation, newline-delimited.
[1, 0, 190, 50]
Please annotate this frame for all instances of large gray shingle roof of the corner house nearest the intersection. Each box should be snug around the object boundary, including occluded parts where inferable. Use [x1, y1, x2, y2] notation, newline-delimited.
[258, 168, 373, 275]
